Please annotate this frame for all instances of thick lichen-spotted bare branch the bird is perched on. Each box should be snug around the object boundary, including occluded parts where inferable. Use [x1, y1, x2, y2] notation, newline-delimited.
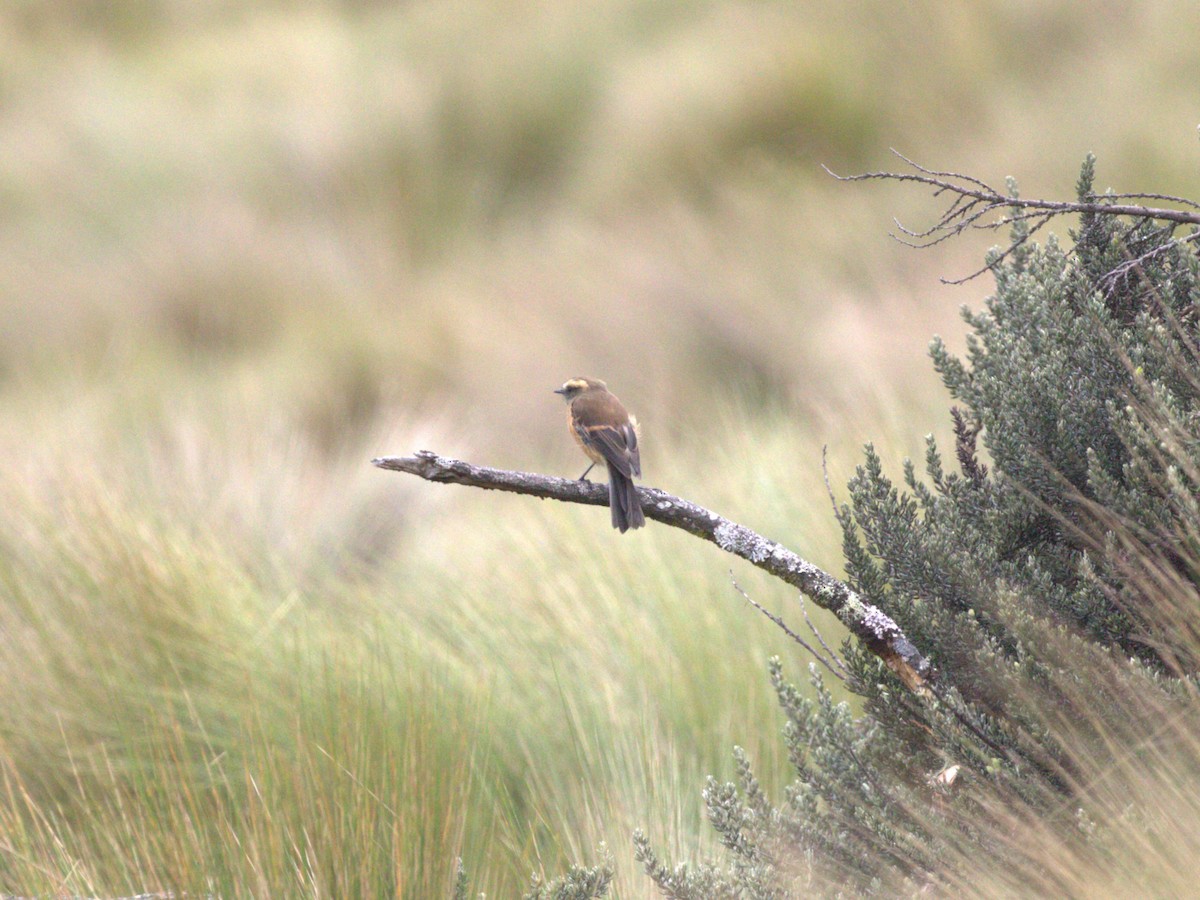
[371, 450, 935, 694]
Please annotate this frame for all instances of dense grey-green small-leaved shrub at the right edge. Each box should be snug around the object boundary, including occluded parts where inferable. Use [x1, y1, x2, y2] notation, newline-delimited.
[635, 157, 1200, 900]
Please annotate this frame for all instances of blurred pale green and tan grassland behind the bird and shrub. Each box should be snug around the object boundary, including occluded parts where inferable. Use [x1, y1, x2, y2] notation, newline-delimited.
[0, 0, 1200, 896]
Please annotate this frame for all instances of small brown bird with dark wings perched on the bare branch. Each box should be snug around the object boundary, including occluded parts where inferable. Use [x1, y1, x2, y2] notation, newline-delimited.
[554, 378, 646, 534]
